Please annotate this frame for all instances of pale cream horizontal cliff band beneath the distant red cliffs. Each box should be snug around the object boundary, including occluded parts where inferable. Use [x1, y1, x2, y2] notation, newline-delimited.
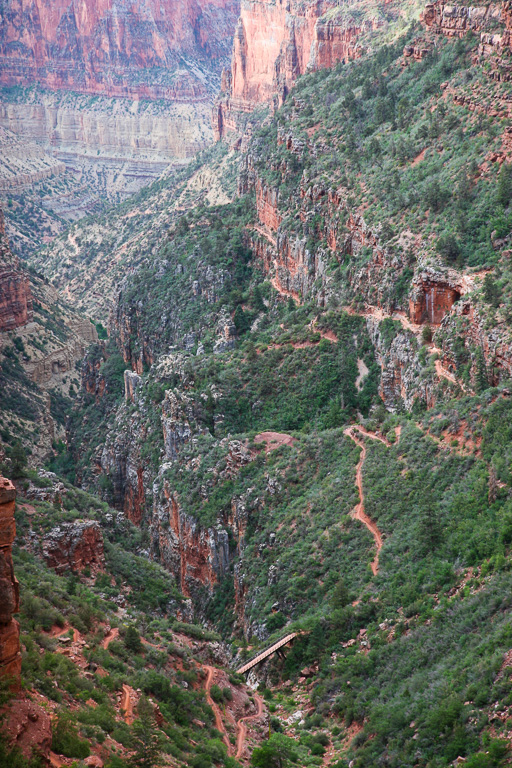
[0, 88, 211, 161]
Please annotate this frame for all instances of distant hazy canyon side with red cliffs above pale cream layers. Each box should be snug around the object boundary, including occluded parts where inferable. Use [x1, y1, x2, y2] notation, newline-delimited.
[0, 0, 239, 255]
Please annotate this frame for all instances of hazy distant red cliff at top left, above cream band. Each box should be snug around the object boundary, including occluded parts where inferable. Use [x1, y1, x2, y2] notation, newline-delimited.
[0, 0, 239, 100]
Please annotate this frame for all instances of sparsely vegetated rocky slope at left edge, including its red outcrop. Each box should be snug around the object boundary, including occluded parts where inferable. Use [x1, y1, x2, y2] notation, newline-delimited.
[0, 204, 98, 464]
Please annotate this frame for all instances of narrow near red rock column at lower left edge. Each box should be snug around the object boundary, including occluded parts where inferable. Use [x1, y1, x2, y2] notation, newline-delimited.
[0, 477, 21, 688]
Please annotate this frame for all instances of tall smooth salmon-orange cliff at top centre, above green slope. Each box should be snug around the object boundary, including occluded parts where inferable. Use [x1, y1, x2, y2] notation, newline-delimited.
[213, 0, 380, 139]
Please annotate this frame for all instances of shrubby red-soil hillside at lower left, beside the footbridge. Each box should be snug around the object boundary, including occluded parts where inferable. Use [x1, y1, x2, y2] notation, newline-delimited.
[0, 471, 266, 768]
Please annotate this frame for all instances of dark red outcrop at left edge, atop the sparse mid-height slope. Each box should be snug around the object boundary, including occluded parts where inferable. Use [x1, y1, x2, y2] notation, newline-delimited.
[0, 210, 32, 332]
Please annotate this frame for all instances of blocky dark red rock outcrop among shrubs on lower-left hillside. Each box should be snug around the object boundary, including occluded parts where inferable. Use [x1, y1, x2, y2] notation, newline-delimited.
[43, 520, 105, 573]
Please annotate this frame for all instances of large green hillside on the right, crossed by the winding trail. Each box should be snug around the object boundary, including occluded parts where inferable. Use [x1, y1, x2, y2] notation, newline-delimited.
[7, 0, 512, 768]
